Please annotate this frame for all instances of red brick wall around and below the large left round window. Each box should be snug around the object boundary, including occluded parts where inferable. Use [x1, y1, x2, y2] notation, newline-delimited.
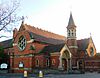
[10, 31, 46, 72]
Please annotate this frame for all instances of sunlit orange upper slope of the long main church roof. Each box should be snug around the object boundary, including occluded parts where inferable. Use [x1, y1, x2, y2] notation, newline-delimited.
[24, 24, 66, 40]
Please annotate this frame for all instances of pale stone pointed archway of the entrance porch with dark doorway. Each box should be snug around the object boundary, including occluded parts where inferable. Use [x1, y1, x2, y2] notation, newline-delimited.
[59, 49, 71, 71]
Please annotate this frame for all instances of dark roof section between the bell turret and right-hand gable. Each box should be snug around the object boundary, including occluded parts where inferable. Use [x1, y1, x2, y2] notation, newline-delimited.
[77, 38, 89, 51]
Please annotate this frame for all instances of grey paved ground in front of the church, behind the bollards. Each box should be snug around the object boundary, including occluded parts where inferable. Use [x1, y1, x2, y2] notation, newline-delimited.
[0, 73, 100, 78]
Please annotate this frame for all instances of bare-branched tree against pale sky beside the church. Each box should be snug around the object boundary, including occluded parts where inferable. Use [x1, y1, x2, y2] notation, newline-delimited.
[0, 0, 21, 38]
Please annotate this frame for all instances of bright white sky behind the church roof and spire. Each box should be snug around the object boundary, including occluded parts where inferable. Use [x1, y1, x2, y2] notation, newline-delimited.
[0, 0, 100, 52]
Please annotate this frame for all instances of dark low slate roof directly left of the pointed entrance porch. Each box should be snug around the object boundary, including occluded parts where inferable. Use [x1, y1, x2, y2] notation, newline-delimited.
[40, 44, 65, 53]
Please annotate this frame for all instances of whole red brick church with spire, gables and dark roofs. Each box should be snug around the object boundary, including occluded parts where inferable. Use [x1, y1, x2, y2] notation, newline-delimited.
[0, 14, 100, 72]
